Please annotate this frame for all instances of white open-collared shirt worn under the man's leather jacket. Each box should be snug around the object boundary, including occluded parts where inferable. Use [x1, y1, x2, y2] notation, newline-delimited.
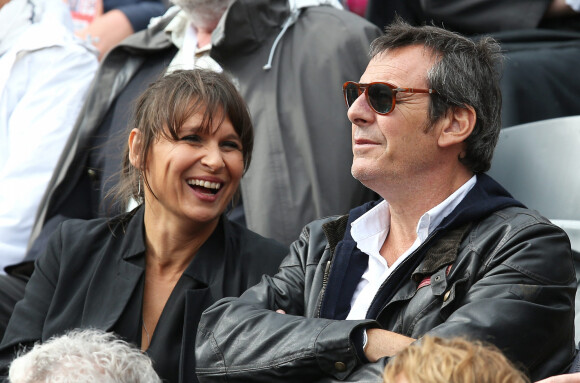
[346, 176, 476, 319]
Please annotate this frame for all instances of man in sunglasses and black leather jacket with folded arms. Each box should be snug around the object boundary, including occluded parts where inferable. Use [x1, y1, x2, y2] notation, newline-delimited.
[196, 21, 576, 382]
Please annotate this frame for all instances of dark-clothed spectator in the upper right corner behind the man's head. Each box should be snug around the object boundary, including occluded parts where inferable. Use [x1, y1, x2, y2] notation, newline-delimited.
[367, 0, 580, 127]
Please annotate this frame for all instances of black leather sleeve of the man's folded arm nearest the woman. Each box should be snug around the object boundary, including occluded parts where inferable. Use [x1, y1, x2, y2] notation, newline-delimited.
[196, 231, 371, 383]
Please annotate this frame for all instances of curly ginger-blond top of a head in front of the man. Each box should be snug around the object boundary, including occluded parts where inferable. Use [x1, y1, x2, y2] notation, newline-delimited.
[384, 336, 529, 383]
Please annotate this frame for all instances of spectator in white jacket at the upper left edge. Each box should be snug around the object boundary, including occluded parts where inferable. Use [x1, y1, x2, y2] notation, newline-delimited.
[0, 0, 98, 273]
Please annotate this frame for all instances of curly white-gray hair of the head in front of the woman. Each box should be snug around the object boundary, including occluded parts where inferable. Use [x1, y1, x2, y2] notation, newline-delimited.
[8, 329, 161, 383]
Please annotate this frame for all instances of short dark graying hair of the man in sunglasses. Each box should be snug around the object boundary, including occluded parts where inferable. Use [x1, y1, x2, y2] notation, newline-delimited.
[370, 18, 503, 173]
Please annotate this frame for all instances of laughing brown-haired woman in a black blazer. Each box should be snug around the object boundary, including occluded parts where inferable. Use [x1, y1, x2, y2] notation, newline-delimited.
[0, 70, 286, 382]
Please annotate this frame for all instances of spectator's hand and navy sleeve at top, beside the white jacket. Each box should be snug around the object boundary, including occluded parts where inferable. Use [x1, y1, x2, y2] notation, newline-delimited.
[65, 0, 166, 59]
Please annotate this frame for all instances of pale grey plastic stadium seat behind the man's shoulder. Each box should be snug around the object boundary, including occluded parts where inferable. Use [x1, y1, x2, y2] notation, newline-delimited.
[488, 115, 580, 344]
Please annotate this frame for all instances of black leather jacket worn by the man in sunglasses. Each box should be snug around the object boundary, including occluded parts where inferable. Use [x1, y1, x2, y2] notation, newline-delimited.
[196, 175, 576, 382]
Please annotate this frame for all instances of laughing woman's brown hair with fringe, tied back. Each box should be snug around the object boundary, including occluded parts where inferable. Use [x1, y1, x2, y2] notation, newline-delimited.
[110, 69, 254, 210]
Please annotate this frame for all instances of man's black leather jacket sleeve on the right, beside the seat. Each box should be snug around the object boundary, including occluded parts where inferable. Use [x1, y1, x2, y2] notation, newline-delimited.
[428, 214, 576, 381]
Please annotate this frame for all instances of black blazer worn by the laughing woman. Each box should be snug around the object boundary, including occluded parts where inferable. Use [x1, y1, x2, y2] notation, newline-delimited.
[0, 207, 287, 383]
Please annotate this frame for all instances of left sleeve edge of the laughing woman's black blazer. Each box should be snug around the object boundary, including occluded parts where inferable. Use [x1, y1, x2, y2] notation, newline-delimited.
[0, 227, 62, 376]
